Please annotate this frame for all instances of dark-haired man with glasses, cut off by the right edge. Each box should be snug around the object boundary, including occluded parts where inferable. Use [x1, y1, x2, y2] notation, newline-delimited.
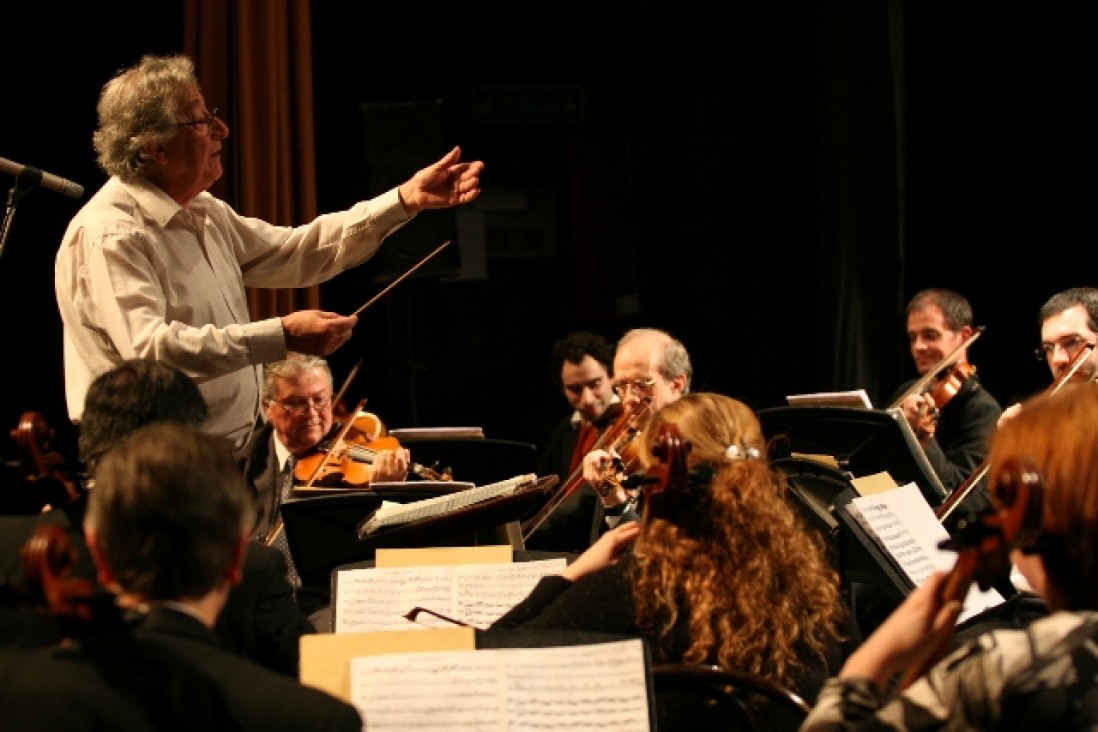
[999, 288, 1098, 426]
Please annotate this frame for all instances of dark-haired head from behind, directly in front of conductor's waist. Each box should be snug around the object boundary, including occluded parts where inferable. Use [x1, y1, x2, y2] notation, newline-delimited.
[77, 359, 208, 471]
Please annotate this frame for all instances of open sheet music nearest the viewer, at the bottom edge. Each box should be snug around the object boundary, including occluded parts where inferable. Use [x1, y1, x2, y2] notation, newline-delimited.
[350, 639, 651, 732]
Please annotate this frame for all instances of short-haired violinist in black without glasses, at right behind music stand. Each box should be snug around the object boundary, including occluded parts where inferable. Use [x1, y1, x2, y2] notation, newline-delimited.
[888, 288, 1002, 500]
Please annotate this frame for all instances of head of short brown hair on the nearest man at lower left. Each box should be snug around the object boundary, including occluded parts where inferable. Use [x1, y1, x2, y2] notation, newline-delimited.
[85, 421, 254, 600]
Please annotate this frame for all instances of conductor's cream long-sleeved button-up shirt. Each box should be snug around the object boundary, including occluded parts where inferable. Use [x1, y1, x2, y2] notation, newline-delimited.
[55, 178, 408, 447]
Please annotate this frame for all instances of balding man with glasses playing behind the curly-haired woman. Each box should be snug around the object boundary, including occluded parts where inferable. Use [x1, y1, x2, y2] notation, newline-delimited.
[583, 328, 694, 540]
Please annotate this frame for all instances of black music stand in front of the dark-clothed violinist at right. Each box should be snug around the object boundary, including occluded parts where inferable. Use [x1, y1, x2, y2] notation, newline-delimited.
[759, 406, 946, 506]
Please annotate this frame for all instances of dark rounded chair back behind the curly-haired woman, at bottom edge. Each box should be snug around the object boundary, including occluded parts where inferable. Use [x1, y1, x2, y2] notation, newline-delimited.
[652, 662, 810, 732]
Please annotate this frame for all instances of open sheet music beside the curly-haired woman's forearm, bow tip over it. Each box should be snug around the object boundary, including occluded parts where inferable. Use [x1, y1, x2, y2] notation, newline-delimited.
[333, 558, 568, 633]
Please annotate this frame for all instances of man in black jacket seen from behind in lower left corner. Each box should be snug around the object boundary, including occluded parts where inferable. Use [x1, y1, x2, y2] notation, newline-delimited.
[0, 421, 362, 732]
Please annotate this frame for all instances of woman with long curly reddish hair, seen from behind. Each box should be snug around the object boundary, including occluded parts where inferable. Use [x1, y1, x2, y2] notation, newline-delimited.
[492, 392, 860, 729]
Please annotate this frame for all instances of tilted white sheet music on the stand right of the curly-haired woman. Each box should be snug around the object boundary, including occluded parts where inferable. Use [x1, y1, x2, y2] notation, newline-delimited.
[849, 483, 1004, 622]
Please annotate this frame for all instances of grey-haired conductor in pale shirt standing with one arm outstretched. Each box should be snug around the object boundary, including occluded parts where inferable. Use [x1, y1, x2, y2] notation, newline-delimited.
[55, 56, 484, 449]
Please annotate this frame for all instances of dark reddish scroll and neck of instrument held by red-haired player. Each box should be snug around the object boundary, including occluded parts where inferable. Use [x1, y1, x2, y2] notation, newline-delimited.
[900, 458, 1044, 689]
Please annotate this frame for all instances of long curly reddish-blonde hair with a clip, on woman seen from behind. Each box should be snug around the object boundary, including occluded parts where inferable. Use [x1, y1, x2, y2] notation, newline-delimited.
[634, 392, 845, 685]
